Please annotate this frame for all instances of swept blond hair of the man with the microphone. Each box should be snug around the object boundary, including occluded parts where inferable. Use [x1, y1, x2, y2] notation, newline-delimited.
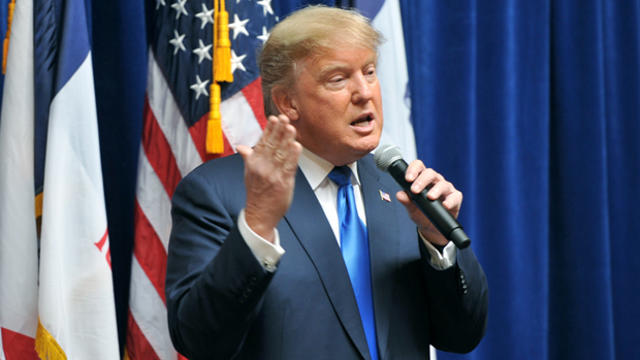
[258, 5, 383, 116]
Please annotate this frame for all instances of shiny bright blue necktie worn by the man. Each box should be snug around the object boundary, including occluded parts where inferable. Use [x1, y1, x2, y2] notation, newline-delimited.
[329, 166, 378, 360]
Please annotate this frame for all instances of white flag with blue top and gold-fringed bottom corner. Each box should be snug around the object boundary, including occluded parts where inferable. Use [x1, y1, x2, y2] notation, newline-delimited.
[36, 0, 120, 359]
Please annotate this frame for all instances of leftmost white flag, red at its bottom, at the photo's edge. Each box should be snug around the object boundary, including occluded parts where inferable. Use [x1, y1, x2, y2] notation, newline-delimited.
[0, 0, 38, 360]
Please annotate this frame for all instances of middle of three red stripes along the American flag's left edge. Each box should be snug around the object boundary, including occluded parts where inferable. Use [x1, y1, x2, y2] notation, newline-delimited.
[133, 200, 167, 306]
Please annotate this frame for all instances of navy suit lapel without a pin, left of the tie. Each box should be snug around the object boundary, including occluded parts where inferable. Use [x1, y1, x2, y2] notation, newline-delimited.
[285, 170, 370, 359]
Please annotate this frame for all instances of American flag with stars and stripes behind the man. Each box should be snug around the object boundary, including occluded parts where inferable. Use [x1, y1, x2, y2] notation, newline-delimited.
[125, 0, 277, 359]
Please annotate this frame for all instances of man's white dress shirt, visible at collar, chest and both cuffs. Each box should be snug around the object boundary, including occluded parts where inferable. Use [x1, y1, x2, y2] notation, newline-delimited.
[238, 148, 456, 271]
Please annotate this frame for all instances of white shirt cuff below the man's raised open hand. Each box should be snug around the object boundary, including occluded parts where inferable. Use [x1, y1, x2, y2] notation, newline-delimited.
[238, 209, 285, 272]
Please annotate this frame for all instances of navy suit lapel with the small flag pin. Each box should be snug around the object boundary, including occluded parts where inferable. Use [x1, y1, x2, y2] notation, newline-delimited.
[358, 156, 398, 358]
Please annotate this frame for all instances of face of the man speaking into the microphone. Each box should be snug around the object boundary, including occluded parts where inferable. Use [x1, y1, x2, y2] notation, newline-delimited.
[291, 44, 383, 165]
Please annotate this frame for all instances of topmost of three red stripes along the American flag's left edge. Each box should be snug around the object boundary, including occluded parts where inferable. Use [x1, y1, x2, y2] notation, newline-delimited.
[142, 98, 182, 198]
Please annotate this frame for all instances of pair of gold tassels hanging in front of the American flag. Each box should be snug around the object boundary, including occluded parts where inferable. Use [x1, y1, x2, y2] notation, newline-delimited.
[206, 0, 233, 154]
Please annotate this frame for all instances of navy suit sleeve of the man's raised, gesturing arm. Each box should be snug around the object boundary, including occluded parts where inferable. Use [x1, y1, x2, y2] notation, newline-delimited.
[166, 162, 273, 360]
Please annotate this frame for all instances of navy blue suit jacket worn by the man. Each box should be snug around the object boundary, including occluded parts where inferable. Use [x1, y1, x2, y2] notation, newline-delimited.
[166, 155, 488, 360]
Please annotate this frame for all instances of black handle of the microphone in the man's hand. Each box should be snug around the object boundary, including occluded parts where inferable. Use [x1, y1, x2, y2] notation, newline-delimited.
[387, 159, 471, 249]
